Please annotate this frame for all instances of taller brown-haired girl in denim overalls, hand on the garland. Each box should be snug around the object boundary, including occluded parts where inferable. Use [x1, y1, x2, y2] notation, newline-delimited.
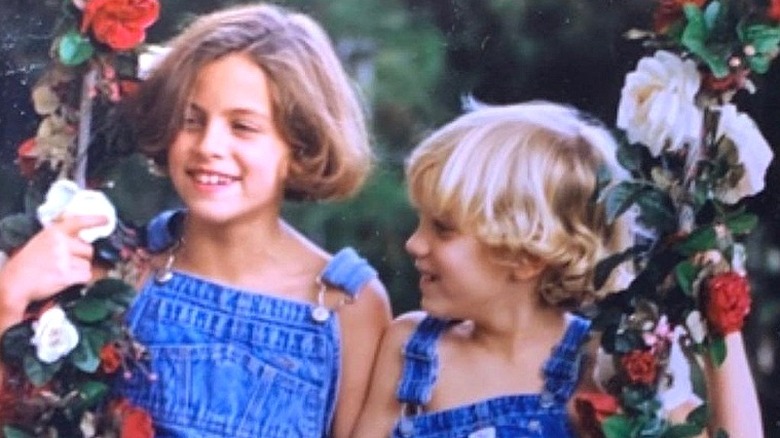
[0, 4, 390, 438]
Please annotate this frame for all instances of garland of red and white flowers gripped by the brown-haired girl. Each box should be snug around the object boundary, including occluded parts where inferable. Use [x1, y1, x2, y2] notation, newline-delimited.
[0, 0, 160, 438]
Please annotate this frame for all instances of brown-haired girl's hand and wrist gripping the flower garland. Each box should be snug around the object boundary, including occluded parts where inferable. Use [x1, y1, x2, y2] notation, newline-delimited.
[0, 215, 108, 331]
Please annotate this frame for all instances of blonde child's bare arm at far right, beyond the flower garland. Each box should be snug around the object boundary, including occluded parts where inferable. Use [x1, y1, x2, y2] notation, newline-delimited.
[705, 332, 764, 438]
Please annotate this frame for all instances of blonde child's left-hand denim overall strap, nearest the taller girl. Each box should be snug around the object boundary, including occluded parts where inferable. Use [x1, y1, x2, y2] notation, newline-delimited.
[396, 316, 453, 406]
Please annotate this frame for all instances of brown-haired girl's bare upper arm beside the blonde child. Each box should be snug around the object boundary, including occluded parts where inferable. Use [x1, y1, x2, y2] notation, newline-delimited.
[331, 280, 392, 438]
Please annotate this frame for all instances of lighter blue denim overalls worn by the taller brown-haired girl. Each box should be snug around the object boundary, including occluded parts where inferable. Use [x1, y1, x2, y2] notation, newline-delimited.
[120, 210, 376, 438]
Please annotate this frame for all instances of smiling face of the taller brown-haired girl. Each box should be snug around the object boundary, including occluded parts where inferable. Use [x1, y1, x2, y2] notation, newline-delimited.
[168, 54, 290, 223]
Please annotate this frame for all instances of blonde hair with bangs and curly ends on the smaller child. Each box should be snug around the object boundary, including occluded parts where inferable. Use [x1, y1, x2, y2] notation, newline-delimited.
[406, 101, 631, 307]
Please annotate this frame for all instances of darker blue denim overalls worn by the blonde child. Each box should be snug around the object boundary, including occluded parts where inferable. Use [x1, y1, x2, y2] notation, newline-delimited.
[392, 316, 590, 438]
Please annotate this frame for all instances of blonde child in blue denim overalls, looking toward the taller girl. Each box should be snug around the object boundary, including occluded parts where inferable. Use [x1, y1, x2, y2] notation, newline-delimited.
[352, 102, 760, 438]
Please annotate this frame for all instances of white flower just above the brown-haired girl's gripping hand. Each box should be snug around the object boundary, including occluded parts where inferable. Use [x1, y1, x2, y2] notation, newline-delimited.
[38, 179, 117, 243]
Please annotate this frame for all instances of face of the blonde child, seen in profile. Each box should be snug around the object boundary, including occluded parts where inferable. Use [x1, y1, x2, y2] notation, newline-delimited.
[406, 212, 514, 319]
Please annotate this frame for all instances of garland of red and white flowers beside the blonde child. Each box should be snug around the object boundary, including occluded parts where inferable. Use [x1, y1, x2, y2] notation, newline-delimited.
[577, 0, 780, 438]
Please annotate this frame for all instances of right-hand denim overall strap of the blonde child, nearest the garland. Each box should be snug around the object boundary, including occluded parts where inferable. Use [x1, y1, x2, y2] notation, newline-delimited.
[542, 315, 590, 404]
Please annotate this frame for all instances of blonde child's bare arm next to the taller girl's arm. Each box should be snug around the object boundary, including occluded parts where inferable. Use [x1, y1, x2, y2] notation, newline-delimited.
[352, 312, 422, 438]
